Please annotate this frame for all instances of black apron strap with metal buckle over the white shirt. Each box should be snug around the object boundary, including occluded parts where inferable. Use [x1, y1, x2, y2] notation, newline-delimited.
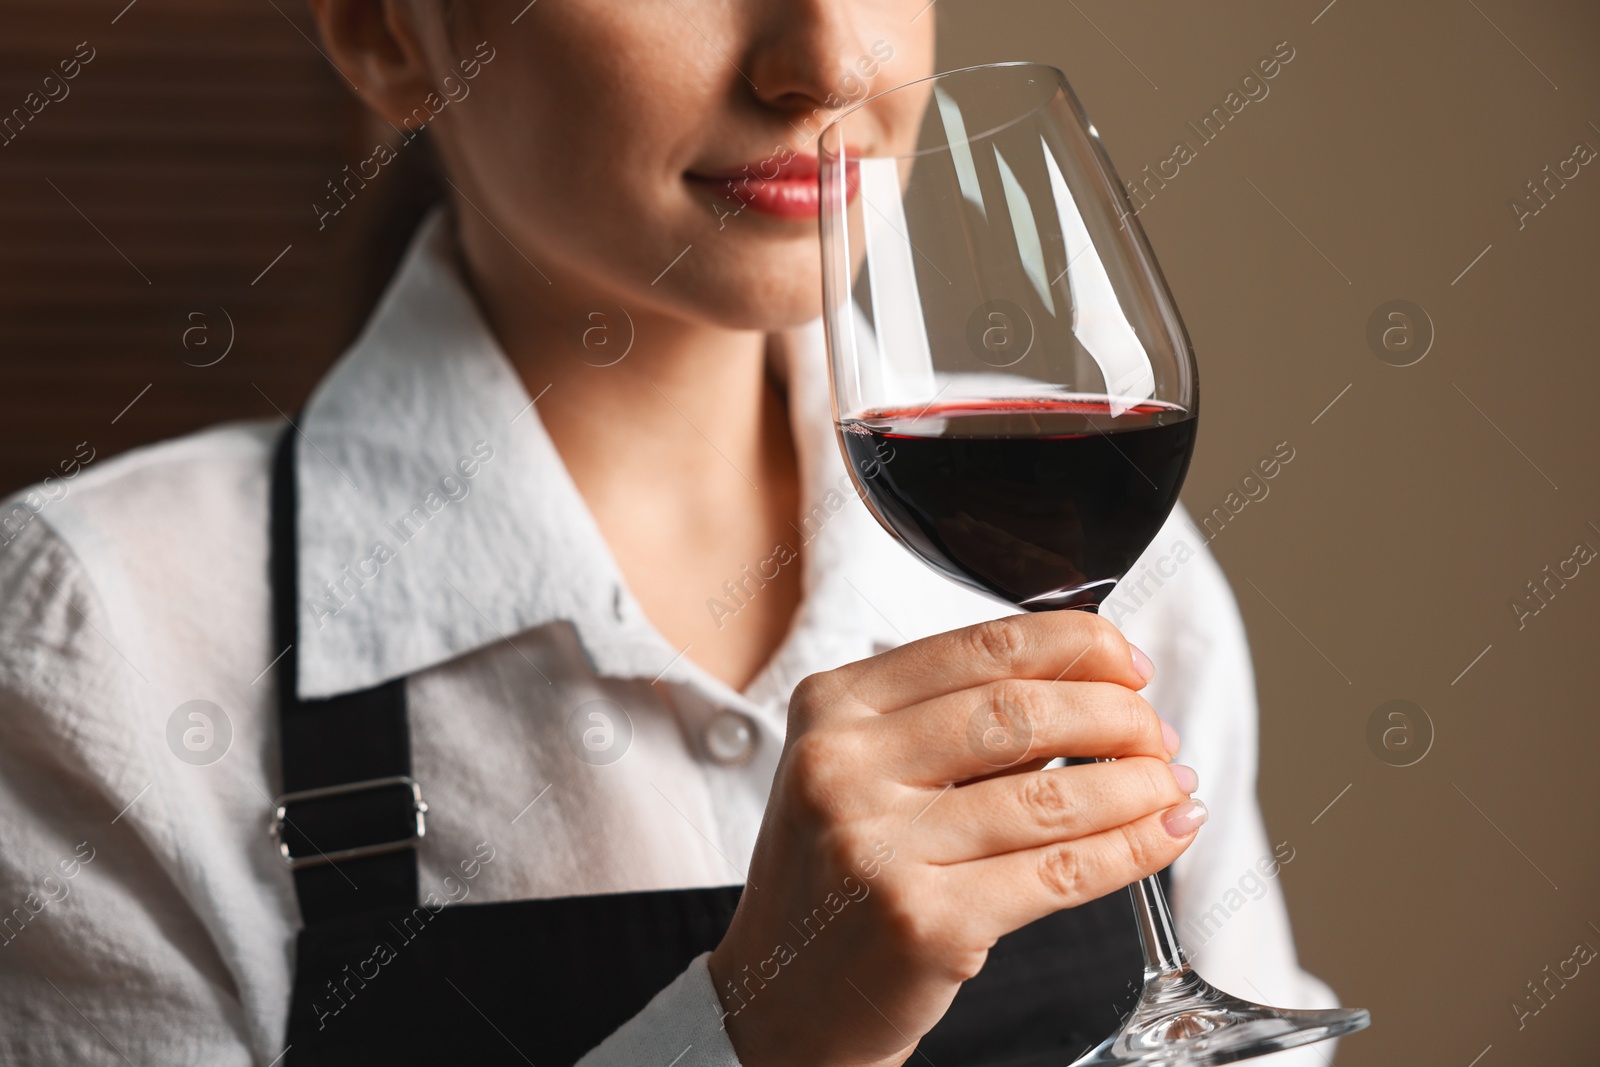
[270, 424, 427, 926]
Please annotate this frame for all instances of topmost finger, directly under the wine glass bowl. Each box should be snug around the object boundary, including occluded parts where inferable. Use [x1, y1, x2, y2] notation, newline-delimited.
[830, 611, 1149, 712]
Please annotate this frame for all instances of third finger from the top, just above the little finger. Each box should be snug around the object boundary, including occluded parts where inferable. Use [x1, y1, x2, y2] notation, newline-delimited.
[907, 757, 1195, 864]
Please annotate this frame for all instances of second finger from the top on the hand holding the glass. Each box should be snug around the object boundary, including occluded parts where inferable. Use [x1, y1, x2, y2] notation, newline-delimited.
[862, 680, 1176, 785]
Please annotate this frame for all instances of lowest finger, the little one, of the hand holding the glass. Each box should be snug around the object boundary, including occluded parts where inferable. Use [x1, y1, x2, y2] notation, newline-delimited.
[942, 790, 1205, 937]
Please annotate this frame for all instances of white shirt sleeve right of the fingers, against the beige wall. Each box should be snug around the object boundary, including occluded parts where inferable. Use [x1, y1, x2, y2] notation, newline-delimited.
[1102, 509, 1338, 1067]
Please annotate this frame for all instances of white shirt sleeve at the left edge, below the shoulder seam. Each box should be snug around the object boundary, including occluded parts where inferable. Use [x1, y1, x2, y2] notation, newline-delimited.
[0, 518, 253, 1067]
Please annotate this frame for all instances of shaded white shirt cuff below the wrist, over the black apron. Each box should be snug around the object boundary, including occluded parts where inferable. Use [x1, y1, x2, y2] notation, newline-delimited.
[578, 952, 739, 1067]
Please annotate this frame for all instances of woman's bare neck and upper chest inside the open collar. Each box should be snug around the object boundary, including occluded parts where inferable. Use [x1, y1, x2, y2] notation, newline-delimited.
[458, 204, 800, 688]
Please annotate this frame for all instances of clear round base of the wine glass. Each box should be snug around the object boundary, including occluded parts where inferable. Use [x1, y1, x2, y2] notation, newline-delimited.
[1072, 966, 1373, 1067]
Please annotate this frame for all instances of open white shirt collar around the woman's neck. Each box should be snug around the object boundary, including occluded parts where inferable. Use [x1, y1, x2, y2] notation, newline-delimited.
[296, 210, 915, 702]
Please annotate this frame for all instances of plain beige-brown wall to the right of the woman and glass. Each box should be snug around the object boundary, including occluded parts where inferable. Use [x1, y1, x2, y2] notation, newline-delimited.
[938, 0, 1600, 1067]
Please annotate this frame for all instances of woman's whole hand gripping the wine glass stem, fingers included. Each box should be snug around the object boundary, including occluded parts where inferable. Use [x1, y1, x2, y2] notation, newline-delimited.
[710, 611, 1205, 1067]
